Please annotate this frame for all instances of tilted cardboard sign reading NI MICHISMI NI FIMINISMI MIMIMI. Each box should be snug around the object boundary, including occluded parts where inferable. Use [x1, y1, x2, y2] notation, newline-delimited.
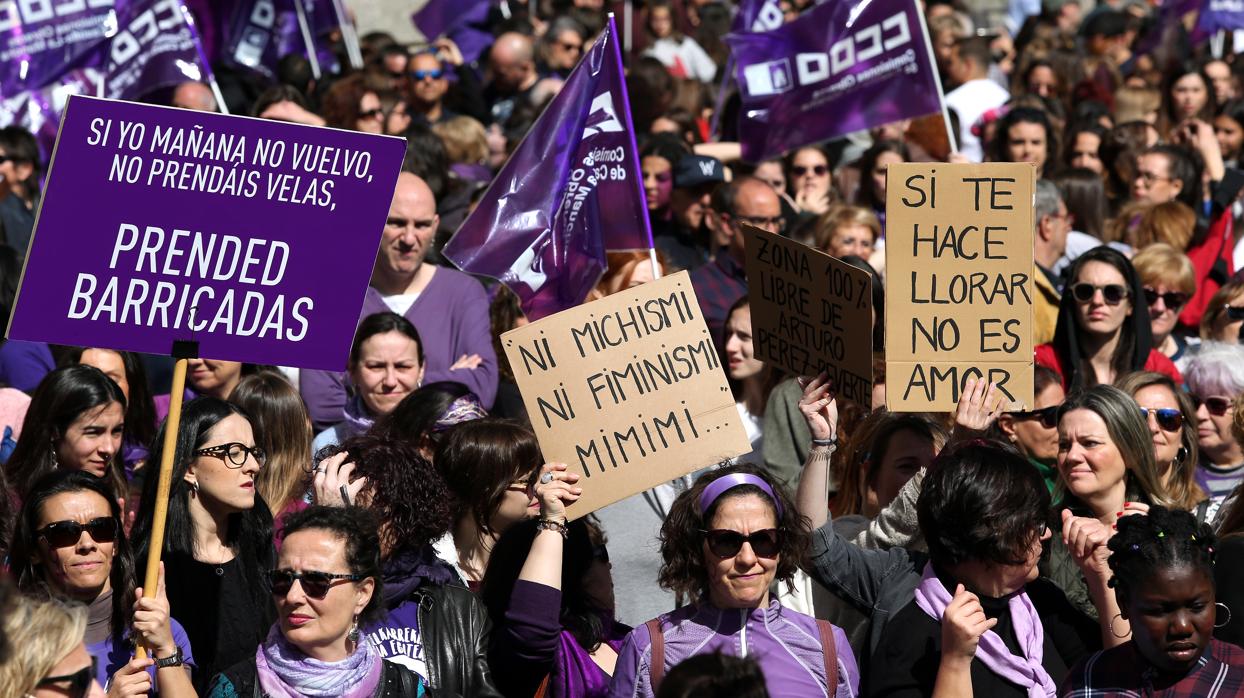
[501, 271, 751, 519]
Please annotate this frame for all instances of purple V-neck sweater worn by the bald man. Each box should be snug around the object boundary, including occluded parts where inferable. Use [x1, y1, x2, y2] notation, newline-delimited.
[299, 266, 498, 430]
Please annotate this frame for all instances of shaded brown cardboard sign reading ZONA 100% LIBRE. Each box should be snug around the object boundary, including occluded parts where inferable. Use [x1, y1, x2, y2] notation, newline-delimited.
[744, 225, 872, 409]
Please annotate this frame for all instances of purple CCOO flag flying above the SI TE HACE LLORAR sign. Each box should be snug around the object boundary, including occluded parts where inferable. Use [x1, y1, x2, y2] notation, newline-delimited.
[725, 0, 942, 162]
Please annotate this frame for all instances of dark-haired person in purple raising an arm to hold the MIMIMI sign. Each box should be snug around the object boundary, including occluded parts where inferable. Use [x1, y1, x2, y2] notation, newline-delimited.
[480, 463, 631, 698]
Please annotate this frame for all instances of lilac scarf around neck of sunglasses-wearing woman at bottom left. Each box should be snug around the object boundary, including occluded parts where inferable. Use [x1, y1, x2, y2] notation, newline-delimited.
[255, 626, 384, 698]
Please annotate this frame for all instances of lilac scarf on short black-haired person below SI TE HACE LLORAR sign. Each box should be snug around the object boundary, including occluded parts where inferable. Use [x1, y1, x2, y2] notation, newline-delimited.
[916, 564, 1057, 698]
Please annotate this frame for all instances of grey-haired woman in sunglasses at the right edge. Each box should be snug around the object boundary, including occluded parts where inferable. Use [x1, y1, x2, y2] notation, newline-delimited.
[1188, 342, 1244, 520]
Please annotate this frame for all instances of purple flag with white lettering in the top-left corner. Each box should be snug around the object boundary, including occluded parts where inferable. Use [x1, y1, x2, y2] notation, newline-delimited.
[0, 0, 114, 96]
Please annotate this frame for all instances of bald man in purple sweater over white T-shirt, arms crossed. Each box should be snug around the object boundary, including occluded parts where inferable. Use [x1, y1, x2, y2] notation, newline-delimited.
[299, 172, 498, 429]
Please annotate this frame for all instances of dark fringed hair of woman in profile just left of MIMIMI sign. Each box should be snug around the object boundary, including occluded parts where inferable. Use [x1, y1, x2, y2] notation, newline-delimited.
[433, 417, 542, 533]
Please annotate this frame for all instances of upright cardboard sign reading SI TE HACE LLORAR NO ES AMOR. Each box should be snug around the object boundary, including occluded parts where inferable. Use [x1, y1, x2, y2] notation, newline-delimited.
[886, 163, 1036, 412]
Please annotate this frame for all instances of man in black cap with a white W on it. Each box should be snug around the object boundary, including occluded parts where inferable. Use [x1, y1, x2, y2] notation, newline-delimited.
[653, 156, 725, 271]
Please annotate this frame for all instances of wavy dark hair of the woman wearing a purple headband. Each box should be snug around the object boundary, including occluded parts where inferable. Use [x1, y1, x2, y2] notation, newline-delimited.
[658, 464, 811, 600]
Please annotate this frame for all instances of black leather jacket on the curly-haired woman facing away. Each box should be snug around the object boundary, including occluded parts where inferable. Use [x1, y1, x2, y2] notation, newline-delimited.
[412, 585, 501, 698]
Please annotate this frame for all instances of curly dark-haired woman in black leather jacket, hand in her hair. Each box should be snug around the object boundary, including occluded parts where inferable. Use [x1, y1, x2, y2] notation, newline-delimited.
[313, 433, 500, 698]
